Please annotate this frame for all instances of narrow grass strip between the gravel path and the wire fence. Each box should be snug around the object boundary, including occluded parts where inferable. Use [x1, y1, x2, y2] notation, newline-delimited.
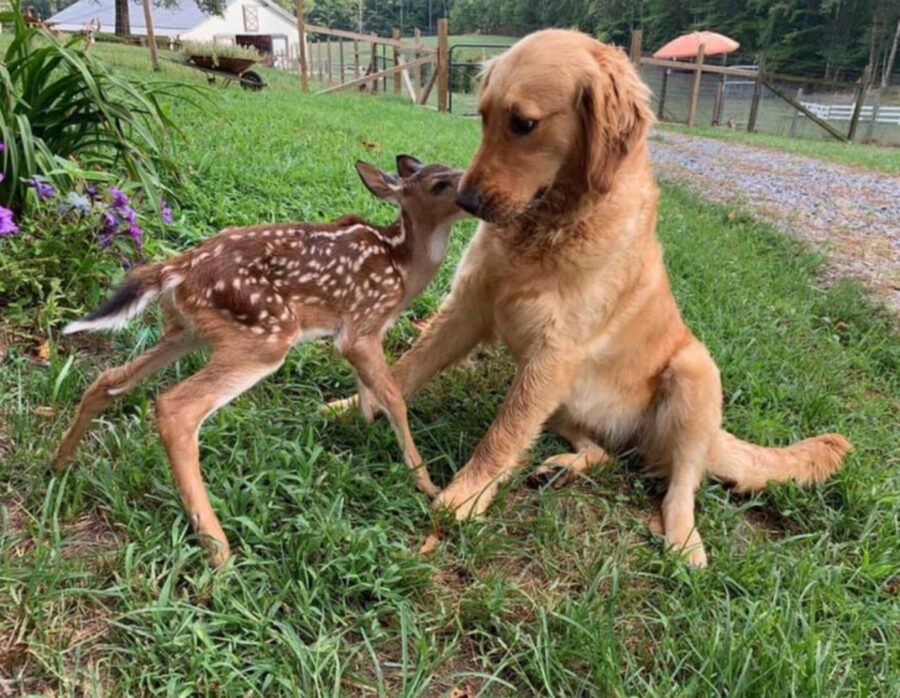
[658, 122, 900, 175]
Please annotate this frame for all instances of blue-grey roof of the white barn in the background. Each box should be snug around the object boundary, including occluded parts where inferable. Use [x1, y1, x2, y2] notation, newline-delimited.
[47, 0, 294, 36]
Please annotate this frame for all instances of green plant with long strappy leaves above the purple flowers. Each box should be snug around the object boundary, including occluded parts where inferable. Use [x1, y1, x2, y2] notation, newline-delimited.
[0, 0, 184, 211]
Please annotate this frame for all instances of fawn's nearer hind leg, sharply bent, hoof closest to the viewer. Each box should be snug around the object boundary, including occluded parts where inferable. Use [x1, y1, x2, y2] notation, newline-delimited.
[156, 346, 286, 566]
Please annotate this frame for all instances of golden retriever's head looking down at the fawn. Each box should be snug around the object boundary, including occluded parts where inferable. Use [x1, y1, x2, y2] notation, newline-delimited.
[457, 29, 653, 223]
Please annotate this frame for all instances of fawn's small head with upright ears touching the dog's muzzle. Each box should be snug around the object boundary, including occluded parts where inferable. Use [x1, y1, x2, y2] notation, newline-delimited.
[356, 155, 466, 235]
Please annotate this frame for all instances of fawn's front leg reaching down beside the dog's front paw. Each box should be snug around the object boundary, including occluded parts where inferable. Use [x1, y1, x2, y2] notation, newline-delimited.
[342, 337, 438, 497]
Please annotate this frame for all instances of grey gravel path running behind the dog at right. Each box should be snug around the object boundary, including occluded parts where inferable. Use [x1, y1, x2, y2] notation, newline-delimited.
[650, 131, 900, 315]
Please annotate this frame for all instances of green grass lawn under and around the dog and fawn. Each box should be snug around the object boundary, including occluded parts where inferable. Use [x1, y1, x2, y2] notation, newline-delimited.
[0, 40, 900, 697]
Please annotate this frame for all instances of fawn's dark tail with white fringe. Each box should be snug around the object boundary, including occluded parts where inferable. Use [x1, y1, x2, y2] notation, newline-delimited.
[63, 264, 182, 334]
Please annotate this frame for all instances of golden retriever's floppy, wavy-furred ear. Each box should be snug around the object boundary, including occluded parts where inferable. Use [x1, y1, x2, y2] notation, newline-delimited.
[580, 41, 654, 194]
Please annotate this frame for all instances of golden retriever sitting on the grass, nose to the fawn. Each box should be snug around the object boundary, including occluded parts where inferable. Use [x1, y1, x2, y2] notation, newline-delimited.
[332, 30, 850, 566]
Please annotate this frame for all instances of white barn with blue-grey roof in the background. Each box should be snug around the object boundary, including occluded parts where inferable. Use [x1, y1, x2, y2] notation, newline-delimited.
[47, 0, 306, 67]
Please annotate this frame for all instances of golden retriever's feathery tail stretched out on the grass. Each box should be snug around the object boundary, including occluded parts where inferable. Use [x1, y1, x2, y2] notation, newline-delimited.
[708, 429, 852, 492]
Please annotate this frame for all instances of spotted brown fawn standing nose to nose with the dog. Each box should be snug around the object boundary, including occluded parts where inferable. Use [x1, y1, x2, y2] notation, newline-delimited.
[54, 155, 465, 565]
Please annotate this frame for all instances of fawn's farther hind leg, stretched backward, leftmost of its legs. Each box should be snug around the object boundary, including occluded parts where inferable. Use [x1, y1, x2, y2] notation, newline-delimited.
[53, 328, 199, 469]
